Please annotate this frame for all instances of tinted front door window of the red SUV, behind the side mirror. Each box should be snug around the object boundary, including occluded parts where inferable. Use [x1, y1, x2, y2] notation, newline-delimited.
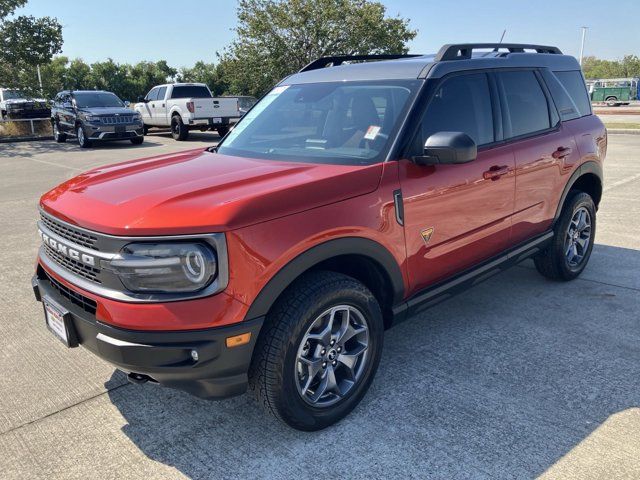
[422, 73, 494, 145]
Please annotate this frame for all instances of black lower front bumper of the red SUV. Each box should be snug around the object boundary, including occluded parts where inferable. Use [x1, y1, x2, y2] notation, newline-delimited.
[32, 268, 264, 399]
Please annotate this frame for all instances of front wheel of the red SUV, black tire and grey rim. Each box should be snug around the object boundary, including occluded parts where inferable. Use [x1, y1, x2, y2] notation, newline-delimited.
[250, 271, 384, 431]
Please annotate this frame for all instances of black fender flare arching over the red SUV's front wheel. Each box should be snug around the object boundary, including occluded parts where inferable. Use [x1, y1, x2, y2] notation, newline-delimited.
[245, 237, 404, 320]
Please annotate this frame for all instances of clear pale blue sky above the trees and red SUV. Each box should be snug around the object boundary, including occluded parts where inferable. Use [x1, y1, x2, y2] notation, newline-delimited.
[16, 0, 640, 67]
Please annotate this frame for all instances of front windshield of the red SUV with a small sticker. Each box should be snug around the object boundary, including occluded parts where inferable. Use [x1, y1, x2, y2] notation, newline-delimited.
[218, 80, 420, 164]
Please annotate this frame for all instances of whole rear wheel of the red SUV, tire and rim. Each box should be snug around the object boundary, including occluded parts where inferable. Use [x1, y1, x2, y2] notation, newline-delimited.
[534, 192, 596, 281]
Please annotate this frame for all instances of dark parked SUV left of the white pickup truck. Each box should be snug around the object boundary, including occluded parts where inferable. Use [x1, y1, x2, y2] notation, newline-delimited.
[51, 90, 144, 148]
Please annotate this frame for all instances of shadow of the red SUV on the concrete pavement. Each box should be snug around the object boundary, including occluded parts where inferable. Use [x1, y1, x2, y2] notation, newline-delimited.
[109, 245, 640, 478]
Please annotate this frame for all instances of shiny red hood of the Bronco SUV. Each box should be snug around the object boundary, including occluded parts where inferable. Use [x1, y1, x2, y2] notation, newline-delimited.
[40, 149, 382, 236]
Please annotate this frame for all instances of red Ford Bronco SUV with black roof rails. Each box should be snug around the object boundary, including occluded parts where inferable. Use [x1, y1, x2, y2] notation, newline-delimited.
[33, 44, 607, 430]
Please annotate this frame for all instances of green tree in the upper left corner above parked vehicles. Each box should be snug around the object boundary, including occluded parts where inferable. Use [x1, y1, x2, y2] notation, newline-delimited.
[0, 0, 62, 91]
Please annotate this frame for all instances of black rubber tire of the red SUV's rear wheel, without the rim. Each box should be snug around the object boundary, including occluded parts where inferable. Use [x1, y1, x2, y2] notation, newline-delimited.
[533, 191, 596, 281]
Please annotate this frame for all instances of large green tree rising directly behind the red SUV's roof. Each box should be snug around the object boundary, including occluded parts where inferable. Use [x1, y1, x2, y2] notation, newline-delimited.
[219, 0, 417, 96]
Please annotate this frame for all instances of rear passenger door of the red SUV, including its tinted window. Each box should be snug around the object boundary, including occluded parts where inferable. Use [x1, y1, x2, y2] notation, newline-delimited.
[496, 69, 579, 244]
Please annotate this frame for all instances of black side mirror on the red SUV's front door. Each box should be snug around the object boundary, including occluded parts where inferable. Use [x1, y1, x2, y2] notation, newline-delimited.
[413, 132, 478, 165]
